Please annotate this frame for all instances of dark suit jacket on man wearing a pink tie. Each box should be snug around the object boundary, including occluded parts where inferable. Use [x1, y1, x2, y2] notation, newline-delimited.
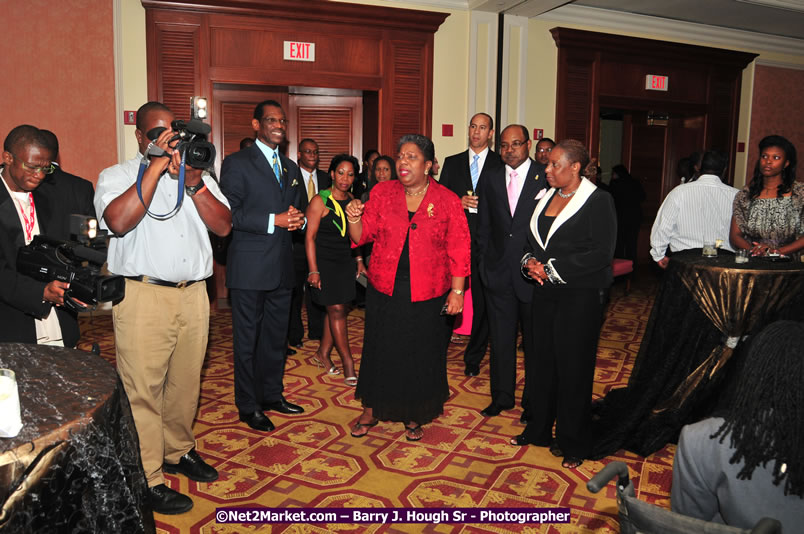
[477, 160, 548, 302]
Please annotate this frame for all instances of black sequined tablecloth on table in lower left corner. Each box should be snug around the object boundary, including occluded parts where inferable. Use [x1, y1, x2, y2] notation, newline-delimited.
[0, 343, 155, 534]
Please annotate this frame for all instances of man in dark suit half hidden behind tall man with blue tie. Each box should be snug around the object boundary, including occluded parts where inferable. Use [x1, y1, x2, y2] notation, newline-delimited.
[288, 139, 332, 348]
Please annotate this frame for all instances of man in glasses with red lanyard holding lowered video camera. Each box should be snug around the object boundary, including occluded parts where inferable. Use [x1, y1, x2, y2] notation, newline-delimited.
[0, 124, 94, 347]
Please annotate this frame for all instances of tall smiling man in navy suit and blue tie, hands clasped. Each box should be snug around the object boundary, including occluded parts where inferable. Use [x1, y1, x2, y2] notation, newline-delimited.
[221, 100, 304, 431]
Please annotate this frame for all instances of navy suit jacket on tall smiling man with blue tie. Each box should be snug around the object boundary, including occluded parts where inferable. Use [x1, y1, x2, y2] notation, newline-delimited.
[221, 143, 306, 291]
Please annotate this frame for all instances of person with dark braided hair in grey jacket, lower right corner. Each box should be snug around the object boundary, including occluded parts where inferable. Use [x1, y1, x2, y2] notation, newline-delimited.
[670, 321, 804, 532]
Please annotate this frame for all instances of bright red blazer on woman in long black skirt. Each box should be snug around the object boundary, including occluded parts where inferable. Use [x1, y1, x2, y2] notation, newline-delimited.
[358, 178, 471, 302]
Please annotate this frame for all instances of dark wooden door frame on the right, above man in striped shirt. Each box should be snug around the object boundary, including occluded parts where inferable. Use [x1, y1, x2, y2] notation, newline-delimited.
[550, 27, 757, 186]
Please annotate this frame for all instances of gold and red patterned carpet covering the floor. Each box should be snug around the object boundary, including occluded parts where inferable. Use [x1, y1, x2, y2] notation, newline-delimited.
[79, 280, 675, 533]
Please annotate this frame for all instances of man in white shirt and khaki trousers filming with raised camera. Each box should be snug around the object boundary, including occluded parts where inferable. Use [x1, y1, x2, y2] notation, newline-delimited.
[95, 102, 231, 514]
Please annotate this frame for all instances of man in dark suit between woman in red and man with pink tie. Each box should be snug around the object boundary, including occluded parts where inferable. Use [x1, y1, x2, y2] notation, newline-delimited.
[440, 113, 502, 376]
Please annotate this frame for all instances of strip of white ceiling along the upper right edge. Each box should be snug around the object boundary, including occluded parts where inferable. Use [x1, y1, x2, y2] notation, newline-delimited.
[416, 0, 804, 40]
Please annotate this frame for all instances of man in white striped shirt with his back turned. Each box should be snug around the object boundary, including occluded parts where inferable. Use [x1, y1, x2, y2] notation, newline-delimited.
[650, 150, 737, 269]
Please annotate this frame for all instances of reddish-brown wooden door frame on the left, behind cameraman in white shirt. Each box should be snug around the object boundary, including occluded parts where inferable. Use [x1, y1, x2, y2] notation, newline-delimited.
[141, 0, 449, 157]
